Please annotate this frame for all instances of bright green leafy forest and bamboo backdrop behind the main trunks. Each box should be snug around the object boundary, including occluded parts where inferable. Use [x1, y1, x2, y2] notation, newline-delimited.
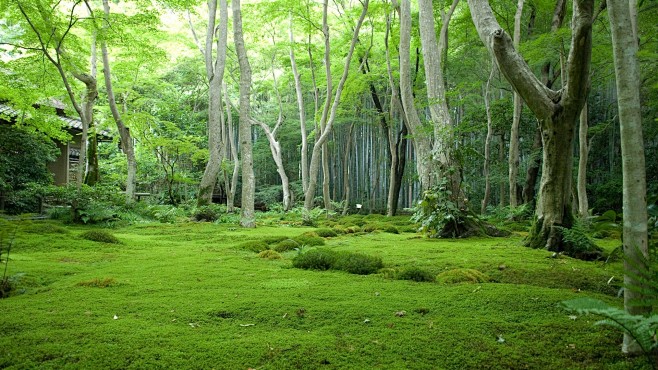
[0, 0, 658, 214]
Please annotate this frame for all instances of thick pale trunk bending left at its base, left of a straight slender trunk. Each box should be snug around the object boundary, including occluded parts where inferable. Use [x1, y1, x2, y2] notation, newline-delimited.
[197, 0, 228, 206]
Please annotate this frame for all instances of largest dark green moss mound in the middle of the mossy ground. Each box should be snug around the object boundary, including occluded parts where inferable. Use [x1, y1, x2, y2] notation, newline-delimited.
[292, 249, 384, 275]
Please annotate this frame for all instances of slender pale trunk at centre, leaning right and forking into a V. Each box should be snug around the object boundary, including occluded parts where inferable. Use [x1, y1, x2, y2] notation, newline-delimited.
[304, 0, 369, 222]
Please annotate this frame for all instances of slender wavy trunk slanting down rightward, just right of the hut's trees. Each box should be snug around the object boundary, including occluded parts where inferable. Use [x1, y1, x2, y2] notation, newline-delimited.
[101, 0, 137, 203]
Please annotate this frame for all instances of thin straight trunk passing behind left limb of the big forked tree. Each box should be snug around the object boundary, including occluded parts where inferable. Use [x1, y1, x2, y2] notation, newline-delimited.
[508, 0, 525, 207]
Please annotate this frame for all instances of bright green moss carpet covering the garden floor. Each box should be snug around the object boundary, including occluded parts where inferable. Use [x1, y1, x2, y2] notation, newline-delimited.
[0, 216, 649, 369]
